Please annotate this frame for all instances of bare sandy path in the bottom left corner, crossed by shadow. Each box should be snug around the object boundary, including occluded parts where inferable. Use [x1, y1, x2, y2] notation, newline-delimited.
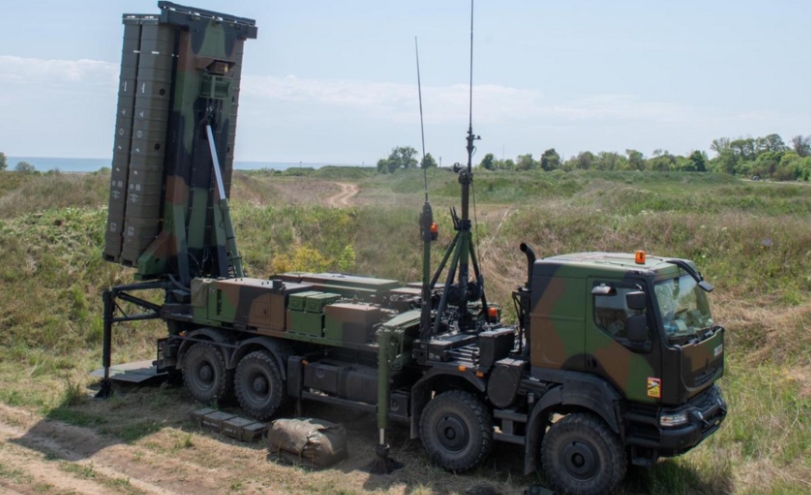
[0, 404, 282, 495]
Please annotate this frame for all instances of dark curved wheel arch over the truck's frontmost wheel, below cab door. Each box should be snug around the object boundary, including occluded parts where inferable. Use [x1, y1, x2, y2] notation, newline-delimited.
[524, 376, 623, 474]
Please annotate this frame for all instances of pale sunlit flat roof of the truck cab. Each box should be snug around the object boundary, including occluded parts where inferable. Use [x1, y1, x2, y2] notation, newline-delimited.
[536, 252, 692, 275]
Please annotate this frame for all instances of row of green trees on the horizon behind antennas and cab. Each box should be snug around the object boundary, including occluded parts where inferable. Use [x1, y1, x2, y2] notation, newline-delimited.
[377, 134, 811, 181]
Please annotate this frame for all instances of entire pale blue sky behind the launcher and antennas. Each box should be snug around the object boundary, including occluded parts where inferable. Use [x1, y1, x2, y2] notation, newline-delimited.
[0, 0, 811, 165]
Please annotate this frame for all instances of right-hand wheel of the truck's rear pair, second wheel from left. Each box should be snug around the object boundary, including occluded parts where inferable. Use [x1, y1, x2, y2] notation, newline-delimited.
[234, 351, 285, 420]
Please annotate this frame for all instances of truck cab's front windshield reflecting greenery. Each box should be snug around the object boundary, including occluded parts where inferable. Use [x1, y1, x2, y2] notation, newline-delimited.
[654, 274, 713, 344]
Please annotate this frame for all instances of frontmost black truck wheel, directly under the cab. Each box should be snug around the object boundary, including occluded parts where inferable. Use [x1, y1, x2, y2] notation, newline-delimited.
[541, 413, 628, 495]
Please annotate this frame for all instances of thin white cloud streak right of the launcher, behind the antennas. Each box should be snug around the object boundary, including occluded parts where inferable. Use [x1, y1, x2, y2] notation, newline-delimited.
[242, 76, 691, 124]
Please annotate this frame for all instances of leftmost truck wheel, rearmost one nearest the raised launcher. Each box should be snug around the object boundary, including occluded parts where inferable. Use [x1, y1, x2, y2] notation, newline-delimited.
[183, 342, 234, 404]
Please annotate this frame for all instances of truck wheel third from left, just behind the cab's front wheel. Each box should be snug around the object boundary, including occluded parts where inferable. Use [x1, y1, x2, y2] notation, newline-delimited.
[420, 390, 493, 472]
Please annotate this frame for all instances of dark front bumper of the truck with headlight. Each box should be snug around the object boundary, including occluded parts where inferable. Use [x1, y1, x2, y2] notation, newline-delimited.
[626, 385, 727, 457]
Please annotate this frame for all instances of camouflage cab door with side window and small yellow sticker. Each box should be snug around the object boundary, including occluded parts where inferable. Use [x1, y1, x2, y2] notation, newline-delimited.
[585, 278, 663, 403]
